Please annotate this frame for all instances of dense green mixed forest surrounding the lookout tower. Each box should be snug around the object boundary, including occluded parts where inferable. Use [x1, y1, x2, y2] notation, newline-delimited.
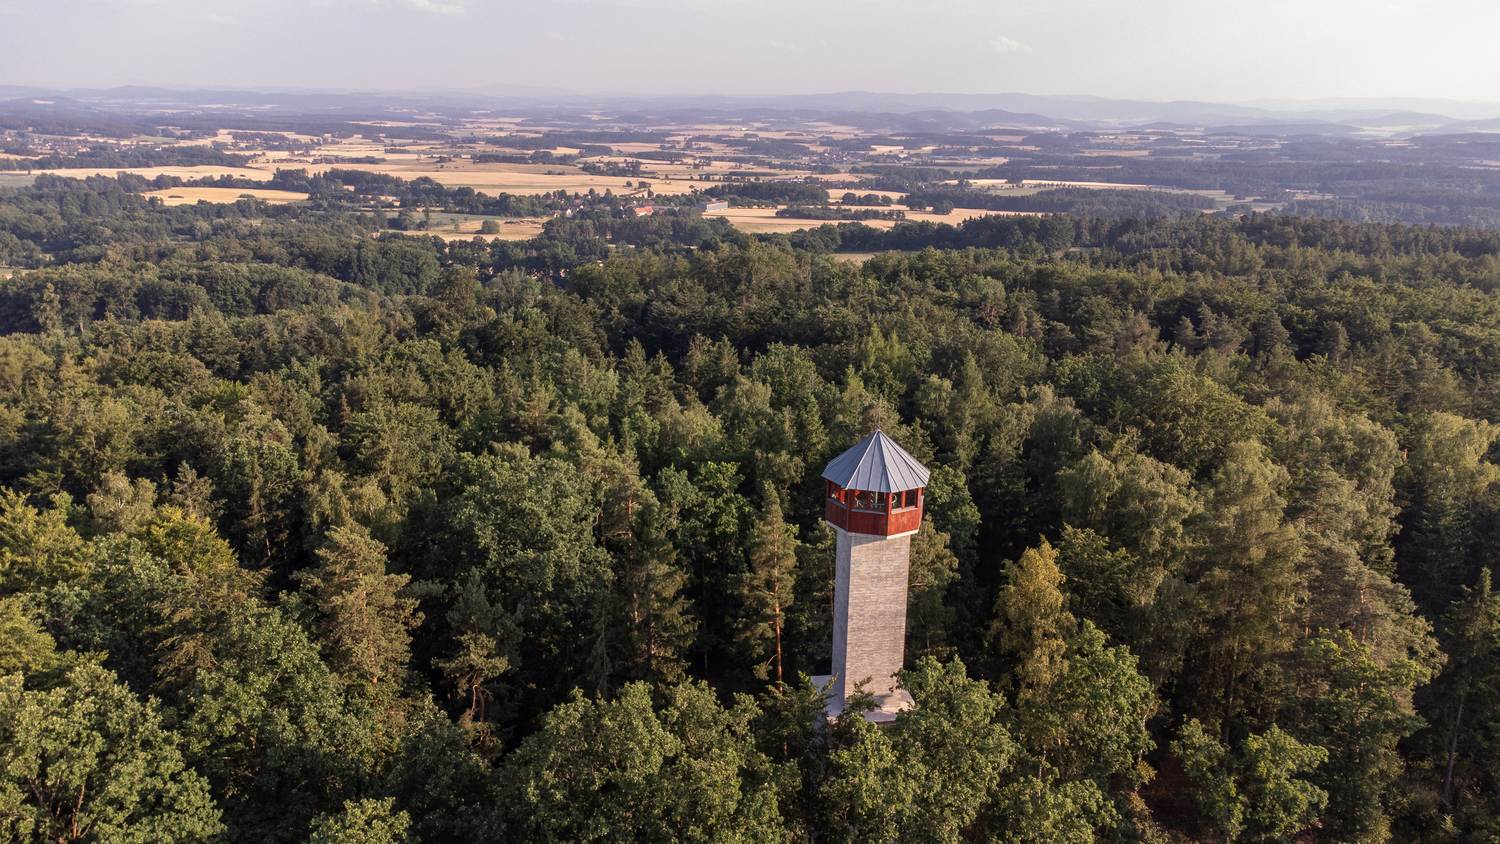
[0, 177, 1500, 843]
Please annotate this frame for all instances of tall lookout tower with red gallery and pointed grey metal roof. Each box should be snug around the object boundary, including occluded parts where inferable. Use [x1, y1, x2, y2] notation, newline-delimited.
[813, 430, 930, 723]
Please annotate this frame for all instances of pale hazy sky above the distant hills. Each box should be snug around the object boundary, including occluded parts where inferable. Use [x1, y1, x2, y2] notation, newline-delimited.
[0, 0, 1500, 100]
